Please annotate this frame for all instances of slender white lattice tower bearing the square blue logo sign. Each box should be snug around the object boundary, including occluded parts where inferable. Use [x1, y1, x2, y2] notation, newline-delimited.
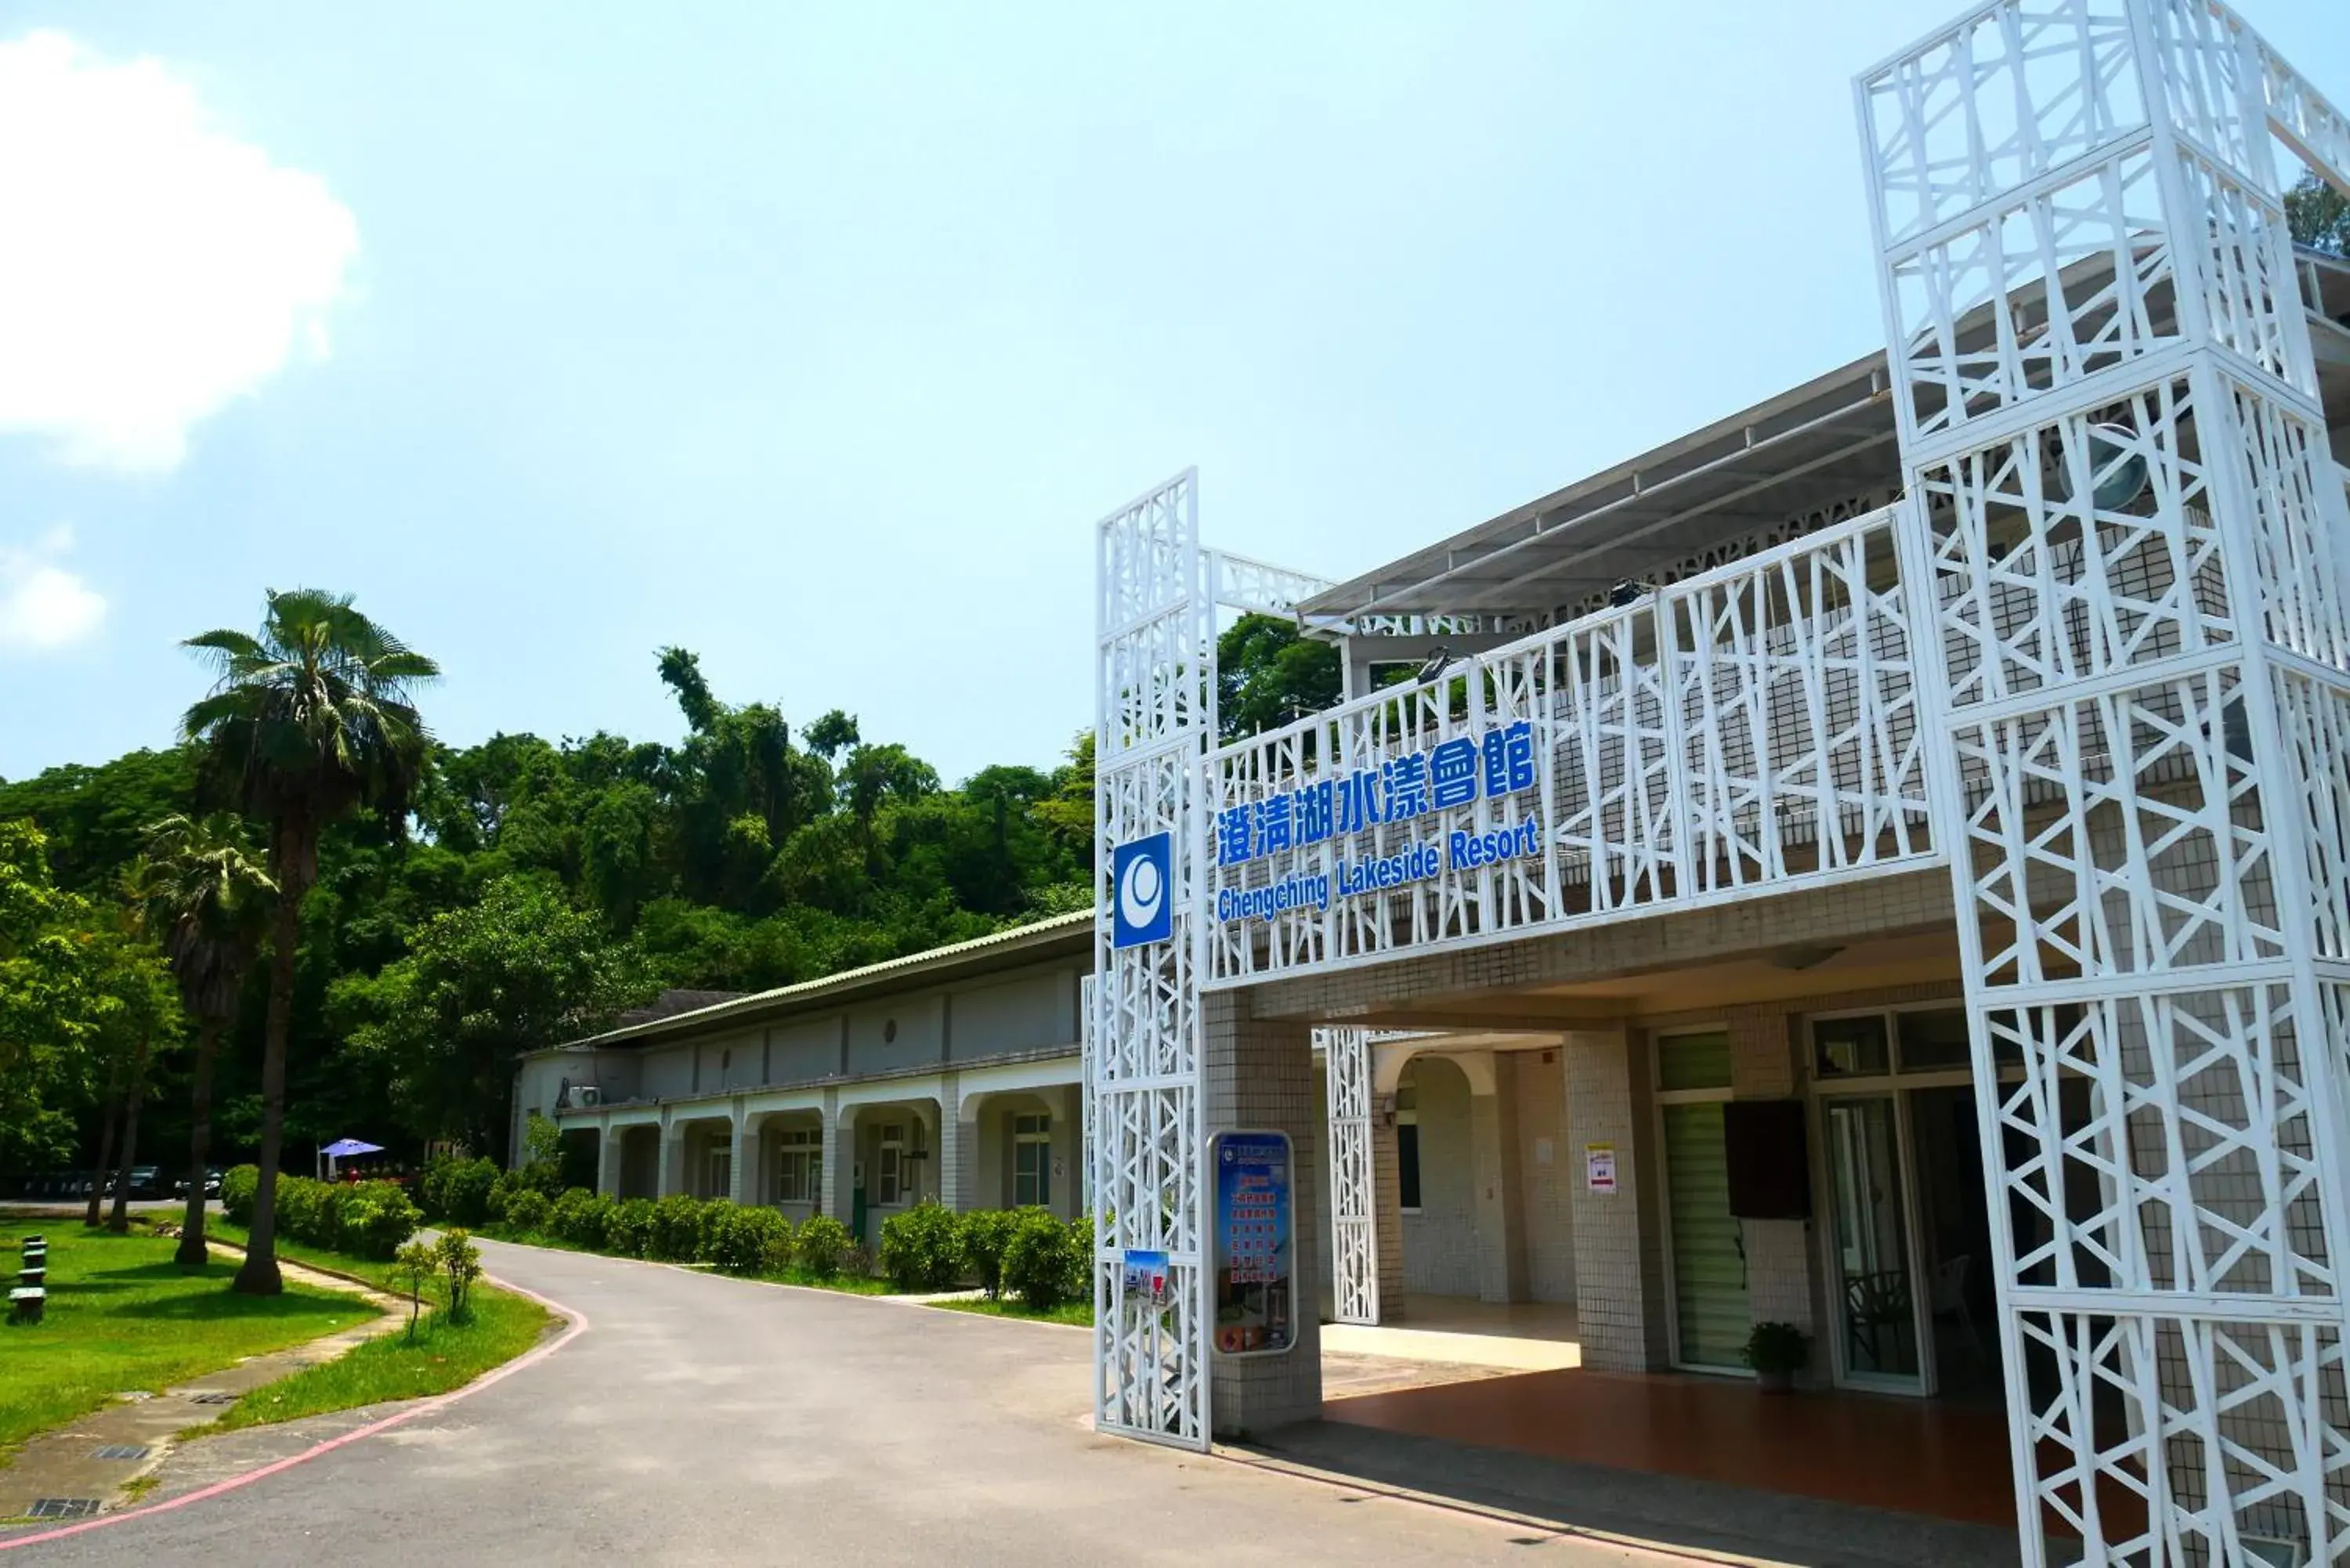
[1086, 470, 1325, 1451]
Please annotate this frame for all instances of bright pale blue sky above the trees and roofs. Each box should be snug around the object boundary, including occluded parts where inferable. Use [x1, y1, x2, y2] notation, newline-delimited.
[0, 0, 2350, 778]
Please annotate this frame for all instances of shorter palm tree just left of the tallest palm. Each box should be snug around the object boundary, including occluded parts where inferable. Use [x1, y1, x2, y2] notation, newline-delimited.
[148, 811, 277, 1270]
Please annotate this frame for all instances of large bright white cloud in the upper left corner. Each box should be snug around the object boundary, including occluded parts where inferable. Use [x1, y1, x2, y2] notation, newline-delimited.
[0, 33, 360, 470]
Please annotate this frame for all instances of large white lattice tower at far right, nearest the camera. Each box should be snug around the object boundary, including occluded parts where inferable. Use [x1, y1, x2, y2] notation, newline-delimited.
[1856, 0, 2350, 1566]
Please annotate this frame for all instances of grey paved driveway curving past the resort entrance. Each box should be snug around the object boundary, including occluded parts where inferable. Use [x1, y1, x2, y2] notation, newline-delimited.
[0, 1244, 1654, 1568]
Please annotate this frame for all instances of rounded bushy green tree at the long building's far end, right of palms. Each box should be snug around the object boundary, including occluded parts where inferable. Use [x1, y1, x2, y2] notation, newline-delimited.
[331, 877, 658, 1157]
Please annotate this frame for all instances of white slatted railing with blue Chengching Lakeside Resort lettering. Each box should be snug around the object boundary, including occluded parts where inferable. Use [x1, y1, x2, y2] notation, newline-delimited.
[1206, 503, 1936, 983]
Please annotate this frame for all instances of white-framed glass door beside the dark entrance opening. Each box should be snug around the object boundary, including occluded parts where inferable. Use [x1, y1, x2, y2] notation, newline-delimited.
[1819, 1093, 1922, 1389]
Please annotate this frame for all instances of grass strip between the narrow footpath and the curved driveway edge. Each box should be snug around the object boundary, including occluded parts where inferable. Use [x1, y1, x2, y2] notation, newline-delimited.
[207, 1220, 555, 1432]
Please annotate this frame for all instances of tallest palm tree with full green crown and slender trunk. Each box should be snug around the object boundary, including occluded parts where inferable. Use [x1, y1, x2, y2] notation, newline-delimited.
[181, 587, 439, 1295]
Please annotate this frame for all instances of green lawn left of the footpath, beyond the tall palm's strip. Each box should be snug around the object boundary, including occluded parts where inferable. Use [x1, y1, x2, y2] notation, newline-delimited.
[0, 1220, 376, 1453]
